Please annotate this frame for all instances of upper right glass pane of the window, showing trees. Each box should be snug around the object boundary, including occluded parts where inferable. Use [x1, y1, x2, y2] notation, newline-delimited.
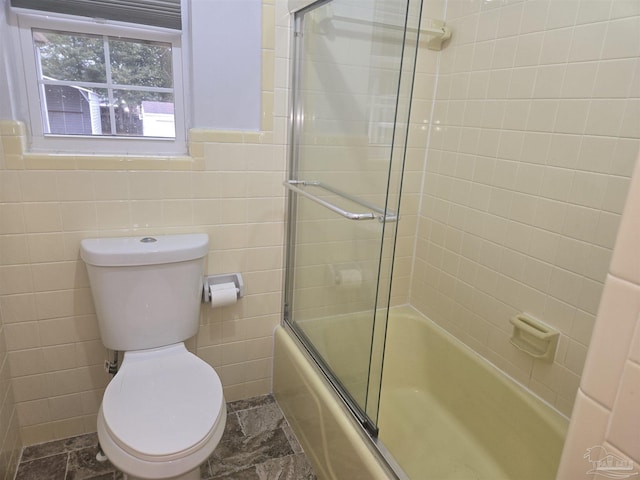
[109, 38, 173, 88]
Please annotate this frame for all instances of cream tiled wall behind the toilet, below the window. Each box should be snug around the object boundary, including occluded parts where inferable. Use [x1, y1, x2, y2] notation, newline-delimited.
[0, 0, 288, 445]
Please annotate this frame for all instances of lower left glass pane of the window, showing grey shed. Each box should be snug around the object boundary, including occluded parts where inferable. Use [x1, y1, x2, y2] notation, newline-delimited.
[43, 85, 110, 135]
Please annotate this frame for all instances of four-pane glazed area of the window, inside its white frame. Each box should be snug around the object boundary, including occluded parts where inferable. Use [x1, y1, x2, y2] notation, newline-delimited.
[32, 29, 175, 138]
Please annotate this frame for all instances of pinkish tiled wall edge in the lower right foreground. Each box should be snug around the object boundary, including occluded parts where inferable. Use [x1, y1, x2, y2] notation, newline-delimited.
[558, 149, 640, 479]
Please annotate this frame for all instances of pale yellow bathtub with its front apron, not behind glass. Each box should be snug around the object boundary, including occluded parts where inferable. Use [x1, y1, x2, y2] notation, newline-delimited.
[273, 306, 568, 480]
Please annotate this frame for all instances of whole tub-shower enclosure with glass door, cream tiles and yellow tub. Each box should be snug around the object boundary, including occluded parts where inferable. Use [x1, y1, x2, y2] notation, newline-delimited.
[282, 0, 640, 480]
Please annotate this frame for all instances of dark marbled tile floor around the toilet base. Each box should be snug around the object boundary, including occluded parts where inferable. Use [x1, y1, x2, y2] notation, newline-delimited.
[16, 395, 316, 480]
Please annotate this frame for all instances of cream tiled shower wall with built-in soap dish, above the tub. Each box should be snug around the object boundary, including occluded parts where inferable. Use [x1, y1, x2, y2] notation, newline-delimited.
[410, 0, 640, 415]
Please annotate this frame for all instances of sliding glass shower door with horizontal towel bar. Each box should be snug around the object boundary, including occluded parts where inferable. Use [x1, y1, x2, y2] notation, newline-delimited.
[285, 0, 420, 434]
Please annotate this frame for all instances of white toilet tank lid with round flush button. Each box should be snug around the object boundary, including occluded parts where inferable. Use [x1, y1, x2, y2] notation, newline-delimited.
[80, 233, 209, 267]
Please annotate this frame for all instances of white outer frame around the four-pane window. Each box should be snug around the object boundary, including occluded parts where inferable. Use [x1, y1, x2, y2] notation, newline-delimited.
[16, 10, 188, 156]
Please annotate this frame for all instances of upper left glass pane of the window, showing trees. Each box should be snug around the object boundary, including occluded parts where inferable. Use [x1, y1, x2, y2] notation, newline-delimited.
[33, 30, 107, 82]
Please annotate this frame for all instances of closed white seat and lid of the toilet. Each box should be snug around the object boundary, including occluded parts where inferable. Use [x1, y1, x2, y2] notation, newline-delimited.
[102, 343, 226, 462]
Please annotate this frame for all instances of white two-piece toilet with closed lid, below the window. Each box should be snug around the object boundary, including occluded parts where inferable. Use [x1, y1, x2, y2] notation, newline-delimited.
[80, 234, 226, 480]
